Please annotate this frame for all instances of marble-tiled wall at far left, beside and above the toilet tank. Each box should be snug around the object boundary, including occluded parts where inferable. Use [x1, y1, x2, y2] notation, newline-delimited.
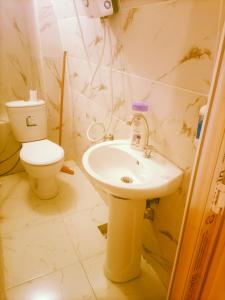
[0, 0, 33, 175]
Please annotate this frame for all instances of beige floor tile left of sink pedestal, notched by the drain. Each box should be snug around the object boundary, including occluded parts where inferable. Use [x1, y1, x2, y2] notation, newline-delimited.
[64, 204, 108, 260]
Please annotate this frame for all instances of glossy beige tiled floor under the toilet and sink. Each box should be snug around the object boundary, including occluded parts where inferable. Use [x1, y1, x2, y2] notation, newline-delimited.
[0, 162, 166, 300]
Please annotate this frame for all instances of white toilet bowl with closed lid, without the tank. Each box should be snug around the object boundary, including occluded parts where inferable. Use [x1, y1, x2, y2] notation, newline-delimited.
[20, 139, 64, 199]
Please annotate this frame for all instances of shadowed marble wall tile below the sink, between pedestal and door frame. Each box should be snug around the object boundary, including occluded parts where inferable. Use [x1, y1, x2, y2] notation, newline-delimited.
[143, 168, 191, 287]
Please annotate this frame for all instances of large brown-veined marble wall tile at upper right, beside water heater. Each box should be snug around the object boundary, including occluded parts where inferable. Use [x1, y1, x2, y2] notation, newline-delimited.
[106, 0, 219, 93]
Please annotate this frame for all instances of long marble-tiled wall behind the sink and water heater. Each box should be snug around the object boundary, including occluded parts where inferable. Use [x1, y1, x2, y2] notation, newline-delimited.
[0, 0, 224, 285]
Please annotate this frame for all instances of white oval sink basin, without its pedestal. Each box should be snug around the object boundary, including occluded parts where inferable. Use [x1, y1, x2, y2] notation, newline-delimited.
[83, 140, 183, 200]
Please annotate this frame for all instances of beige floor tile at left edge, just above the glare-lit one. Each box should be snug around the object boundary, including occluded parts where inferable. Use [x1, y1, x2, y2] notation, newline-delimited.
[1, 219, 77, 288]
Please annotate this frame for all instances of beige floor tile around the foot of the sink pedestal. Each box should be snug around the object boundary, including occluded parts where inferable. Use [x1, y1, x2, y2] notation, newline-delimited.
[82, 255, 166, 300]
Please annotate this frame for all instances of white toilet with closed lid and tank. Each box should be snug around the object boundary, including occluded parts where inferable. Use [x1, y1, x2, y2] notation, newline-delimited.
[6, 99, 64, 199]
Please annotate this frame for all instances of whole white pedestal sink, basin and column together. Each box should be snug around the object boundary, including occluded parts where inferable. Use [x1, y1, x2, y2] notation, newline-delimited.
[83, 140, 182, 282]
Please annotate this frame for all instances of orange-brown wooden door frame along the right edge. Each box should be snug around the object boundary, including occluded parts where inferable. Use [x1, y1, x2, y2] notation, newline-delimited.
[168, 27, 225, 300]
